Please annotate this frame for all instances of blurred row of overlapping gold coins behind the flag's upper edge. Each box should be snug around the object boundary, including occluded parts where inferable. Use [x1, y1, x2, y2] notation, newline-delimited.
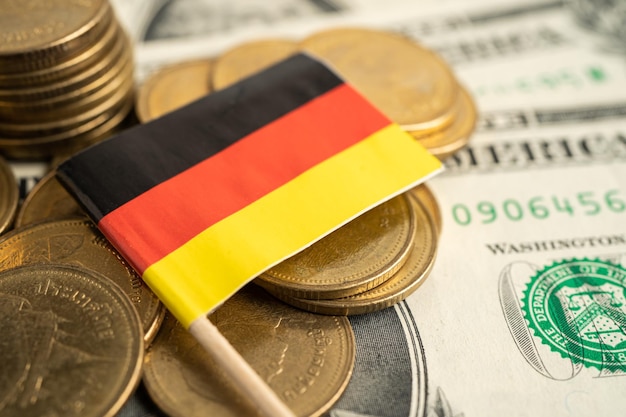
[136, 28, 477, 159]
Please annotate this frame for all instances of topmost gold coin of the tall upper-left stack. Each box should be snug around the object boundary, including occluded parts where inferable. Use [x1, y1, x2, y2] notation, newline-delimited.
[0, 0, 113, 74]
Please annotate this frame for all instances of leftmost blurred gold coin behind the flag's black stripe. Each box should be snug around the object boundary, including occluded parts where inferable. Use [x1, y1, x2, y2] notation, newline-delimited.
[135, 59, 213, 123]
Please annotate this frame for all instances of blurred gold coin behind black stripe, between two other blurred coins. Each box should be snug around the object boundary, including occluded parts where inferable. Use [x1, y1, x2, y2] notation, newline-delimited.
[213, 39, 299, 90]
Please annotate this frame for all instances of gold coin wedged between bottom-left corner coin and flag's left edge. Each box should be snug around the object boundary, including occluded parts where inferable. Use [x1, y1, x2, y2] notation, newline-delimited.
[0, 219, 165, 343]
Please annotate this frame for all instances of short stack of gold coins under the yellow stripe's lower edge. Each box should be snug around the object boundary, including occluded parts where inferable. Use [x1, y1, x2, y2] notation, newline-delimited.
[254, 185, 441, 315]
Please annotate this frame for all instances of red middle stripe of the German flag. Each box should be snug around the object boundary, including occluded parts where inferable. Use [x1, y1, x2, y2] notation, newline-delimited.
[98, 84, 391, 274]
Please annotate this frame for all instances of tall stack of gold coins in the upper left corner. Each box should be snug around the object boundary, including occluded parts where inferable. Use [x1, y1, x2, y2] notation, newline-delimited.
[0, 0, 133, 158]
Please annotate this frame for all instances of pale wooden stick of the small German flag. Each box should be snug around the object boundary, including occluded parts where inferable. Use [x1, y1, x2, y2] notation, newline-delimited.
[189, 316, 295, 417]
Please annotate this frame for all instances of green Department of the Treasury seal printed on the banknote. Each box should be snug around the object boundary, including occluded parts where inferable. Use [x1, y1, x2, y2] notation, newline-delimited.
[522, 259, 626, 372]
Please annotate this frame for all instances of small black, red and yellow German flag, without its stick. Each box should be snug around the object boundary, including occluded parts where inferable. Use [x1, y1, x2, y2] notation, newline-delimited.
[57, 54, 441, 327]
